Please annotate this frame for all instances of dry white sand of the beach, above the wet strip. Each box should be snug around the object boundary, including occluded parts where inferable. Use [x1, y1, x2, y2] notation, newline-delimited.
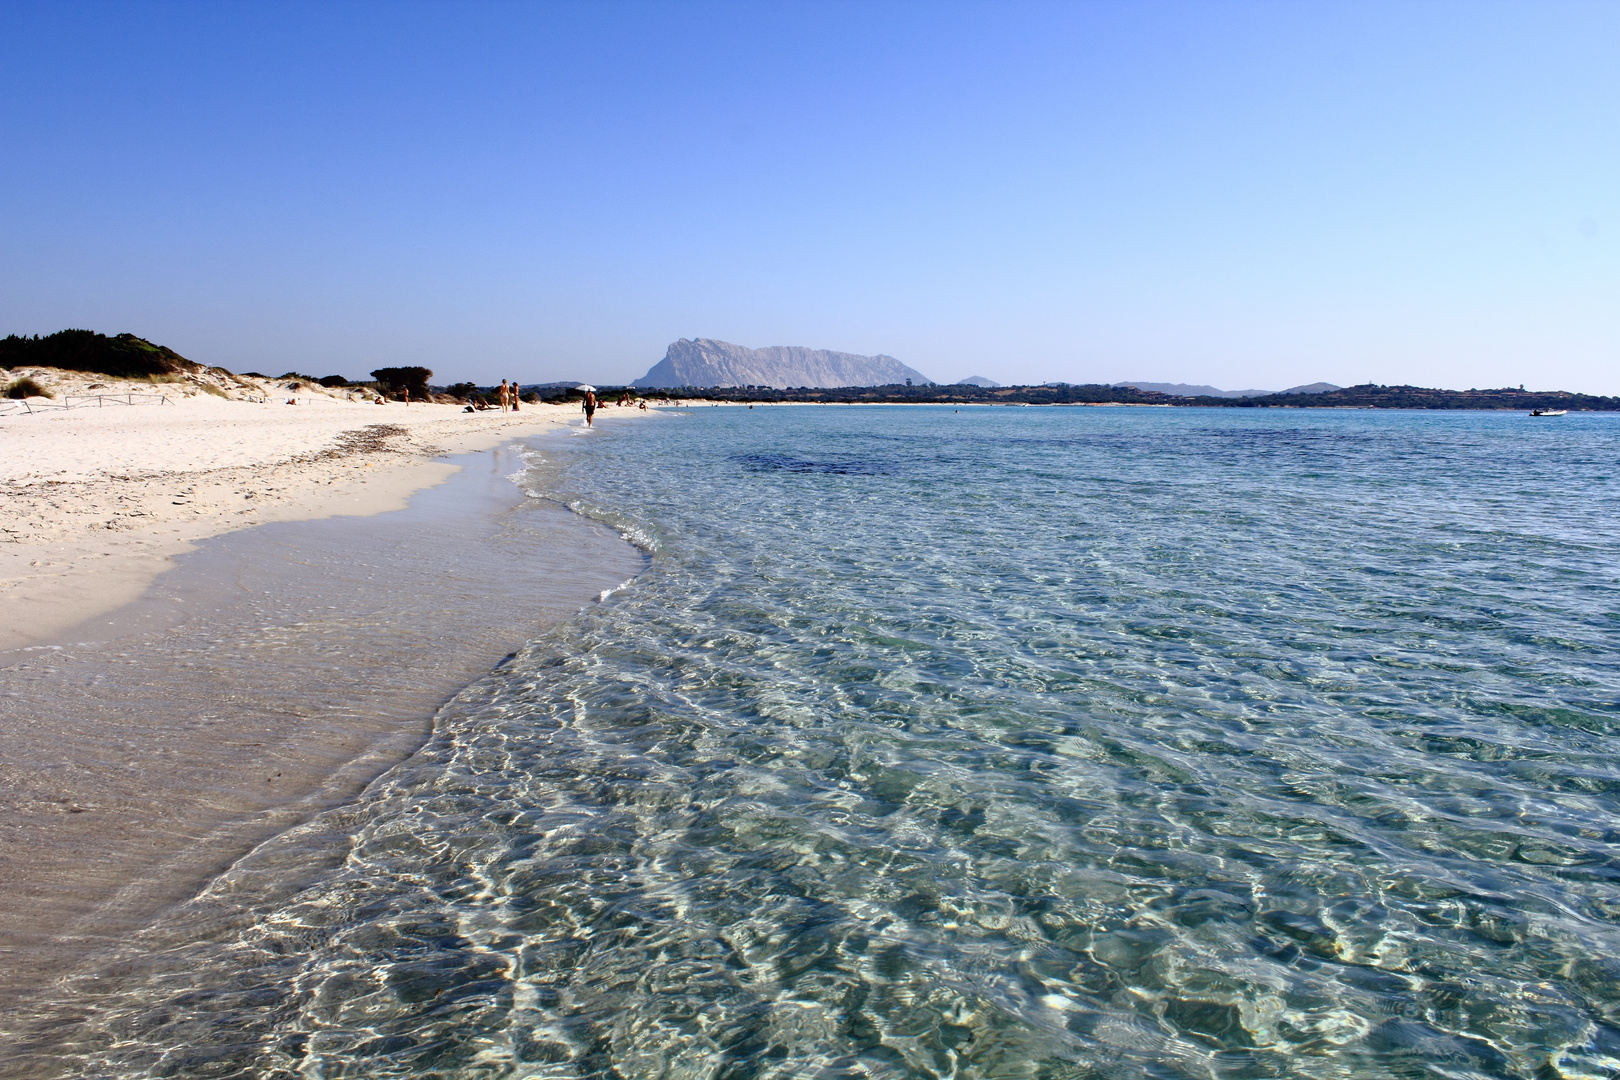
[0, 369, 642, 651]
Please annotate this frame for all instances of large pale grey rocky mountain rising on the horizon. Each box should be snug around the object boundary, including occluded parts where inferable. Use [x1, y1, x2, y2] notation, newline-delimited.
[630, 337, 930, 389]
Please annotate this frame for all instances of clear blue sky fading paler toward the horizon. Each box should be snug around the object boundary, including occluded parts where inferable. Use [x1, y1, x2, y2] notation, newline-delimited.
[0, 0, 1620, 393]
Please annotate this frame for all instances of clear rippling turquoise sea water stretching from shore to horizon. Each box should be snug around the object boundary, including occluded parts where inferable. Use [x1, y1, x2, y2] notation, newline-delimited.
[12, 408, 1620, 1077]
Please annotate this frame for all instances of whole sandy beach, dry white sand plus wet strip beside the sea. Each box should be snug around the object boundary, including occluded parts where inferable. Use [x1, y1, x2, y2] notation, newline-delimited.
[0, 380, 643, 1029]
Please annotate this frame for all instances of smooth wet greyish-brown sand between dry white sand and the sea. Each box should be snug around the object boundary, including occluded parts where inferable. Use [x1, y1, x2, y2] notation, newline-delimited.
[0, 436, 645, 1030]
